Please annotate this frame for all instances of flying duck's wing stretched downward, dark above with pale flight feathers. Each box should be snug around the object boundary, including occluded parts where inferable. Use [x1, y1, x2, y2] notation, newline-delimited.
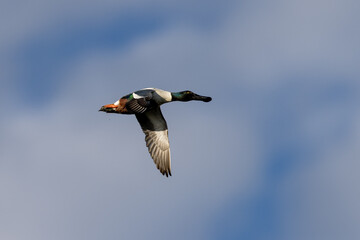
[135, 107, 171, 177]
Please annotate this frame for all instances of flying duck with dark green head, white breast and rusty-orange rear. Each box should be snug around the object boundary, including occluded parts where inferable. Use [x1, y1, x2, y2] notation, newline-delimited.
[99, 88, 212, 177]
